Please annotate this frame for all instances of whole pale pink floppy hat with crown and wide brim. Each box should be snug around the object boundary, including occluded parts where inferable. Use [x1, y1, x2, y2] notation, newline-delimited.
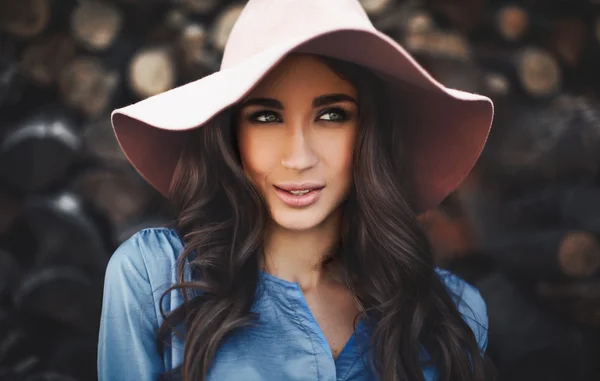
[112, 0, 494, 212]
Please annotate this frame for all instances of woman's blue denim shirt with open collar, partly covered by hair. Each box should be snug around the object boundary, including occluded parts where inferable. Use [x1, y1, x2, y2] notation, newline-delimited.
[98, 228, 487, 381]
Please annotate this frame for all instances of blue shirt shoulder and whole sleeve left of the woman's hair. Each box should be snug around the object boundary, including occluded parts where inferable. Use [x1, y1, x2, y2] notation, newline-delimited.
[98, 228, 182, 381]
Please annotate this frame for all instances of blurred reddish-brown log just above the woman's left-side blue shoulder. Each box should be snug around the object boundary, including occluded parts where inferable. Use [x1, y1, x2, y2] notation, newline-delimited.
[68, 167, 154, 226]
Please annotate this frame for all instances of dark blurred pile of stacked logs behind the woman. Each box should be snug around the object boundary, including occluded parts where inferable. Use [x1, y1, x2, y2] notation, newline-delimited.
[0, 0, 600, 381]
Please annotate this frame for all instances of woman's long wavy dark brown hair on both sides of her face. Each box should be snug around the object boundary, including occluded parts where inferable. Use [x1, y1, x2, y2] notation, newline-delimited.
[158, 53, 486, 381]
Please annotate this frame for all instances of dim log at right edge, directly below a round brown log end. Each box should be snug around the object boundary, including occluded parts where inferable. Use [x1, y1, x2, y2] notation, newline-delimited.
[536, 279, 600, 327]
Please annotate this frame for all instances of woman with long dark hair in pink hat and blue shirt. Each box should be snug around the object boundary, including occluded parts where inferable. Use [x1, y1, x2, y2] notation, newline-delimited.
[98, 0, 492, 381]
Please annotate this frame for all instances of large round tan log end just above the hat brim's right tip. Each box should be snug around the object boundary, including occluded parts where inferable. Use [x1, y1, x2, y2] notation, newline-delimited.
[517, 48, 561, 97]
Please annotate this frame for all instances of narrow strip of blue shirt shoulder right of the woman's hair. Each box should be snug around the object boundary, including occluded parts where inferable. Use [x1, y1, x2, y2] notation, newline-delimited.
[436, 268, 488, 351]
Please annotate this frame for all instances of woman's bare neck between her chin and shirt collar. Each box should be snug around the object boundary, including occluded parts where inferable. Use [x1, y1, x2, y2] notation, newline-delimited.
[263, 209, 341, 291]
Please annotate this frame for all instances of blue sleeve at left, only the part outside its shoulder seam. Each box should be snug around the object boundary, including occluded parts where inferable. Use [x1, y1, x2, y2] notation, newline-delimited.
[98, 234, 164, 381]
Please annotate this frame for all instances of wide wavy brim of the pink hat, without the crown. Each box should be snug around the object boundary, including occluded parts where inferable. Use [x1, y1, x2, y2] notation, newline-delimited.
[111, 29, 494, 212]
